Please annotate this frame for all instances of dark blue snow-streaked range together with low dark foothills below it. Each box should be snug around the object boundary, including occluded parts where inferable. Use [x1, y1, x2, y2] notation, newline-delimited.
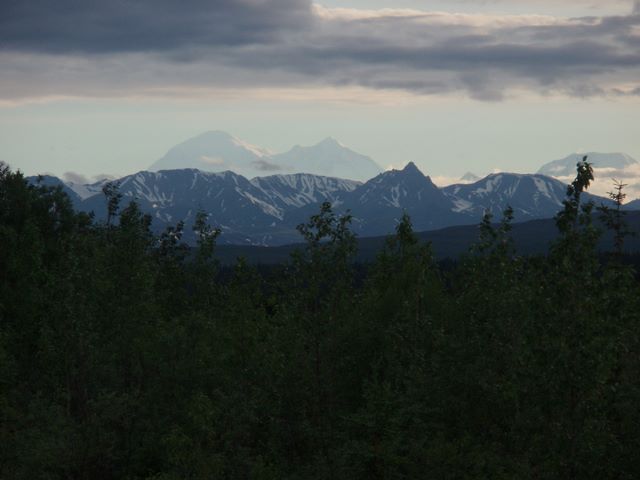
[28, 169, 640, 258]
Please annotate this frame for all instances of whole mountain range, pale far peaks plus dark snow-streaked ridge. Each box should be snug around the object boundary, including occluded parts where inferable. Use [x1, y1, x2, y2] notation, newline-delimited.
[30, 131, 640, 246]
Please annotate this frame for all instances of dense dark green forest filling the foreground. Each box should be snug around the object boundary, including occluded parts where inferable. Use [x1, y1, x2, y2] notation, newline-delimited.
[0, 162, 640, 480]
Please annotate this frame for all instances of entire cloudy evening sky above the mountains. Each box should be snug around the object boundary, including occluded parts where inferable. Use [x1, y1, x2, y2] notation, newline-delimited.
[0, 0, 640, 192]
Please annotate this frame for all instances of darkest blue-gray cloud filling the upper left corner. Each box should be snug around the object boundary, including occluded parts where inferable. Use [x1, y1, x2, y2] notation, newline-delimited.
[0, 0, 310, 53]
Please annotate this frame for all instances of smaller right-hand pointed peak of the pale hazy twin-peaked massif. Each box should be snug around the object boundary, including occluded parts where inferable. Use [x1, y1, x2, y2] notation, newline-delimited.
[271, 138, 382, 181]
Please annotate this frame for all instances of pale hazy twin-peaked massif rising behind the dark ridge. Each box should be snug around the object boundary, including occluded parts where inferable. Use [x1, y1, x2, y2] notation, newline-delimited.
[149, 131, 382, 180]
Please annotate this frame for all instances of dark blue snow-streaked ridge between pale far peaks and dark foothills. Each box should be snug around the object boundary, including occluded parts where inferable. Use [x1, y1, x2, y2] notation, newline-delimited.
[30, 163, 620, 245]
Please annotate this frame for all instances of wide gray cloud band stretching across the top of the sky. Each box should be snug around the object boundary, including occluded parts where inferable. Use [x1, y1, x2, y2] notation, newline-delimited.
[0, 0, 640, 103]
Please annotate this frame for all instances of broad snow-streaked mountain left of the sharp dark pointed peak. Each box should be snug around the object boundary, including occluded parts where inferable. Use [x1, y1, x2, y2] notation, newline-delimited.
[73, 169, 359, 244]
